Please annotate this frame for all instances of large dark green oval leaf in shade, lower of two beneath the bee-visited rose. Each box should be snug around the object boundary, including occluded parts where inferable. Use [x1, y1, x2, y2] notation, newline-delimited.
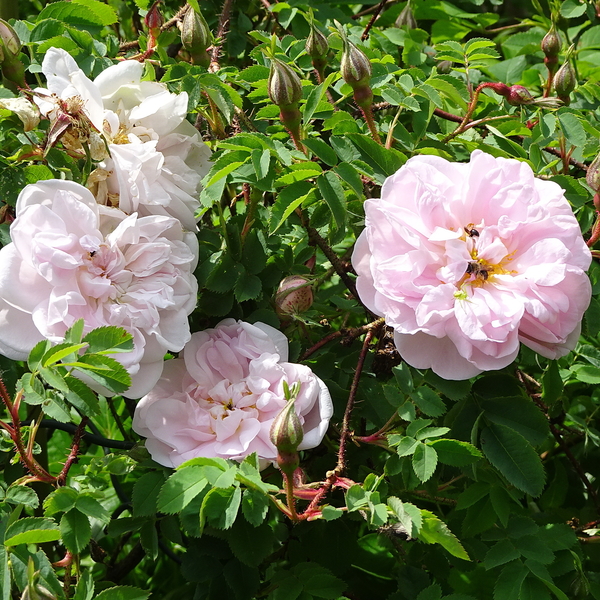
[481, 423, 545, 497]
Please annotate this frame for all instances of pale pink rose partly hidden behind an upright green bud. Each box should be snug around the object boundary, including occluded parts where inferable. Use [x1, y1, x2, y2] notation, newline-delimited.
[133, 319, 333, 467]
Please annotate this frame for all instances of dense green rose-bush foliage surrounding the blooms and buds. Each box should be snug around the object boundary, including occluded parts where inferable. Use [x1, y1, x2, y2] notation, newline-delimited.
[0, 0, 600, 600]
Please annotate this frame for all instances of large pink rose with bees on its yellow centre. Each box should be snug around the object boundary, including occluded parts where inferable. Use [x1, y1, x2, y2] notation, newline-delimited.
[352, 150, 591, 379]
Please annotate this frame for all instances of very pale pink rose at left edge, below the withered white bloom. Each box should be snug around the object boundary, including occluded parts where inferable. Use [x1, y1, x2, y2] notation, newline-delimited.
[0, 180, 197, 398]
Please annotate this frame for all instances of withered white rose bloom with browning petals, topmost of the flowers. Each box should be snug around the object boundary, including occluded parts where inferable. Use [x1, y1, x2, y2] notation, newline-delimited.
[34, 48, 211, 231]
